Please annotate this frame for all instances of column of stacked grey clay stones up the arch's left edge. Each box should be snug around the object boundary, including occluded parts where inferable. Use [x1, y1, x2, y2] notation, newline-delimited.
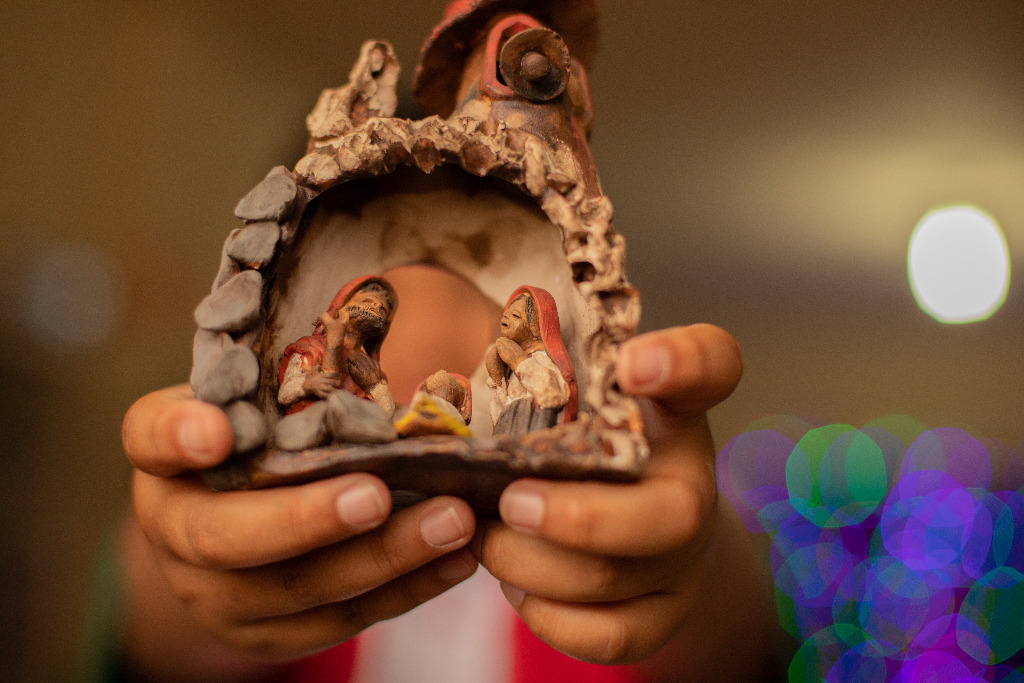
[190, 166, 299, 453]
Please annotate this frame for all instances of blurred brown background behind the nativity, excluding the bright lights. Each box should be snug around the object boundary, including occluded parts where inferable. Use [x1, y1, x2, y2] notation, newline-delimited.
[0, 0, 1024, 681]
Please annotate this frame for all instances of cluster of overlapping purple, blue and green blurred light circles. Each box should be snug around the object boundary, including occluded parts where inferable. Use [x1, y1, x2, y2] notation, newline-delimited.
[718, 416, 1024, 683]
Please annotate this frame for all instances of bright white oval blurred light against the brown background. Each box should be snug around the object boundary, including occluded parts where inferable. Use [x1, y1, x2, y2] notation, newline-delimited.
[907, 206, 1010, 323]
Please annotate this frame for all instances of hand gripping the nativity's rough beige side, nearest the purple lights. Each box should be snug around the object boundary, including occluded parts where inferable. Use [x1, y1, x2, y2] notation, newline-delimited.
[474, 325, 742, 664]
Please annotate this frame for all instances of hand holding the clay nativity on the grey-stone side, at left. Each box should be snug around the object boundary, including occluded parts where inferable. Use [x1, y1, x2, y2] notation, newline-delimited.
[122, 386, 477, 660]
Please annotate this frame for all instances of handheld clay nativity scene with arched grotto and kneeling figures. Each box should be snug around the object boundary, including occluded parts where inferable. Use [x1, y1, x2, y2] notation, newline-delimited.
[191, 0, 647, 512]
